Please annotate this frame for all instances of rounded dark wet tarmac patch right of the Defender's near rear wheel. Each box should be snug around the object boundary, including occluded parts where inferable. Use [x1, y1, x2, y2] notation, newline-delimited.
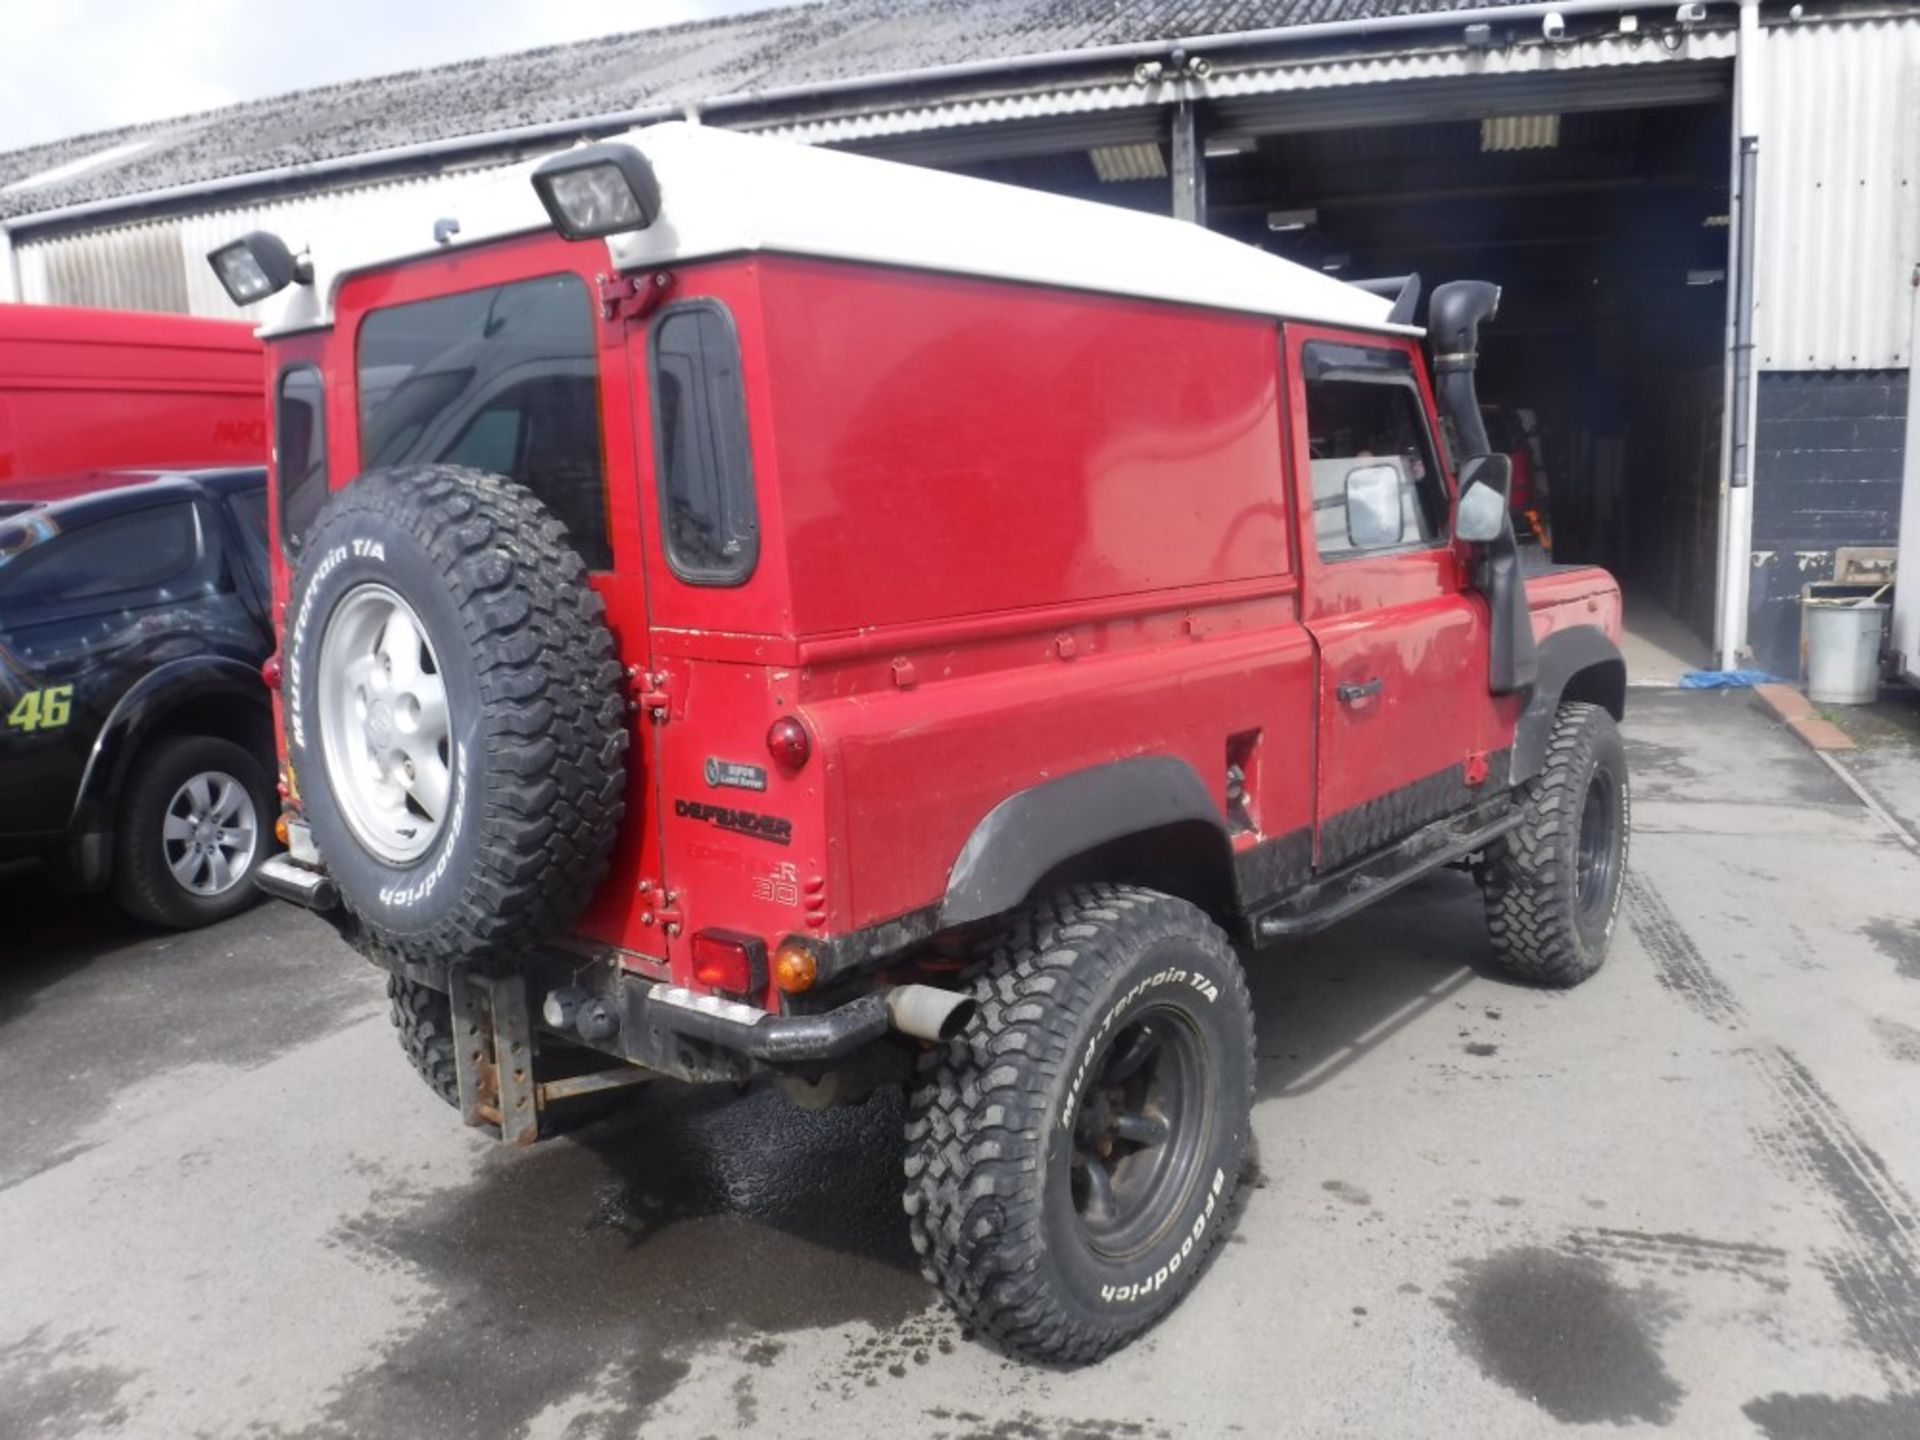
[1436, 1246, 1682, 1425]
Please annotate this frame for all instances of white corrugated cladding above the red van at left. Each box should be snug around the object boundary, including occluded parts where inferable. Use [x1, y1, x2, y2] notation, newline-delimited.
[13, 171, 518, 321]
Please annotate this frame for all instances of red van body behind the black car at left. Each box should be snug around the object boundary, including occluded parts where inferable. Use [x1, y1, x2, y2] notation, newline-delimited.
[0, 305, 267, 484]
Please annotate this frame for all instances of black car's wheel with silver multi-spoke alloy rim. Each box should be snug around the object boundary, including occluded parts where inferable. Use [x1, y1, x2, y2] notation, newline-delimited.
[113, 735, 280, 929]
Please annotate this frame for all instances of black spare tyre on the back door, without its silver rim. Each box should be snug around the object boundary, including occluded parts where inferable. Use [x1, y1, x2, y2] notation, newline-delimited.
[284, 465, 628, 964]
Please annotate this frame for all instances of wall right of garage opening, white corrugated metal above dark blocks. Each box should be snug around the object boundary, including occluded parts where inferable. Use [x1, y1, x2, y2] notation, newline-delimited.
[1747, 13, 1920, 676]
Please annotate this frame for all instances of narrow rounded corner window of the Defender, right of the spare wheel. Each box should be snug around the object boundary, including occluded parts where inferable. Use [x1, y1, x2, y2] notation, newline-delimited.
[649, 300, 760, 586]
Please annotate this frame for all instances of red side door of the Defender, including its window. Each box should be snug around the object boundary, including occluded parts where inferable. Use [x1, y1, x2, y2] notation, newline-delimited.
[1286, 326, 1492, 870]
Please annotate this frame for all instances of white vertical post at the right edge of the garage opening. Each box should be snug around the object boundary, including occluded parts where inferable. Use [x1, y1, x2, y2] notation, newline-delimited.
[1715, 0, 1763, 670]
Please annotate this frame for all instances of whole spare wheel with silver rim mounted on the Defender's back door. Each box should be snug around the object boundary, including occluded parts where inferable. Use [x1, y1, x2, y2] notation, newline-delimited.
[284, 465, 628, 964]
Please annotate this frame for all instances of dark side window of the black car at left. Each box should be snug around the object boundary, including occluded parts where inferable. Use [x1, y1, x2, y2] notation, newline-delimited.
[0, 499, 223, 612]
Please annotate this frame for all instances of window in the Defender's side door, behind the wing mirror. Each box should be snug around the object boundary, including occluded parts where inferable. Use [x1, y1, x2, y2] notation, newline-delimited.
[1302, 342, 1448, 559]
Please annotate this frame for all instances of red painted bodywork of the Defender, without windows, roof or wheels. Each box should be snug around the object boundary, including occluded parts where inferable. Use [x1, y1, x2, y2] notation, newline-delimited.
[275, 236, 1619, 1002]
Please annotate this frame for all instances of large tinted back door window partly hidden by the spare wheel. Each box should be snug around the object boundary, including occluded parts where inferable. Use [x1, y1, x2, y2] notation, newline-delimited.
[359, 275, 612, 570]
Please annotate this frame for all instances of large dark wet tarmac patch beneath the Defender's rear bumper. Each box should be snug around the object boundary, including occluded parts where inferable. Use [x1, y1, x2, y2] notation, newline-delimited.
[309, 1083, 935, 1440]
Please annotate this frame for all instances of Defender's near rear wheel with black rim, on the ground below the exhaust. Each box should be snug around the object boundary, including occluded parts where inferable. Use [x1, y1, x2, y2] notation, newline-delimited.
[904, 885, 1254, 1363]
